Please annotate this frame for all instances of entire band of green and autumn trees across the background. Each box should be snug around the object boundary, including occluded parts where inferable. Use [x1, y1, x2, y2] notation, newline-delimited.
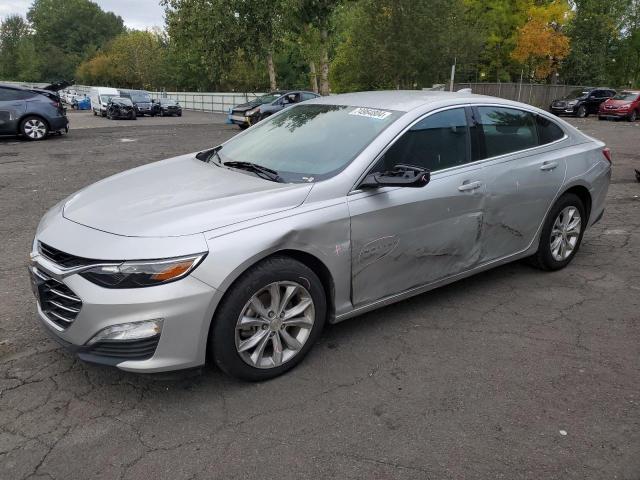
[6, 0, 640, 93]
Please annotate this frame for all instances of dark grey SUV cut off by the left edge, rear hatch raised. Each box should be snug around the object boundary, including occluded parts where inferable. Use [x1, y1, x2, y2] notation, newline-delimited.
[0, 84, 69, 140]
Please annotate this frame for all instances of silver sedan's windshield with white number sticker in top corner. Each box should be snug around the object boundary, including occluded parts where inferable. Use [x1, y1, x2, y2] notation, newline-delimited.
[218, 105, 402, 183]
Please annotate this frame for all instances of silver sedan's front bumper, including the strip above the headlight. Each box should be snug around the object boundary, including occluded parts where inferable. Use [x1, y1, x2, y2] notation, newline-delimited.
[29, 212, 222, 373]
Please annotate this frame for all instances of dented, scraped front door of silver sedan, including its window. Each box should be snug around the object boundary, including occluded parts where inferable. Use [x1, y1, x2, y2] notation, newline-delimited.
[348, 108, 485, 306]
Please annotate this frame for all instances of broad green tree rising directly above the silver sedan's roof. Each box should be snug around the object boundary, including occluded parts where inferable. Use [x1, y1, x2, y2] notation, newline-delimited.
[331, 0, 481, 91]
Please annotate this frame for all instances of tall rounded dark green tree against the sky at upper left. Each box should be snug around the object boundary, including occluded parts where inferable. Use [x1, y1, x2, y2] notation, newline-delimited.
[27, 0, 124, 81]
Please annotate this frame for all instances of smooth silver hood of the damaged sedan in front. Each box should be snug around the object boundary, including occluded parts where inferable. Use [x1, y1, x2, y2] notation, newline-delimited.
[63, 154, 312, 237]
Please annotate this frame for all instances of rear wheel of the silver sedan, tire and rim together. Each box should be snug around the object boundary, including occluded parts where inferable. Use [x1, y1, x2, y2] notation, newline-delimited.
[530, 193, 588, 271]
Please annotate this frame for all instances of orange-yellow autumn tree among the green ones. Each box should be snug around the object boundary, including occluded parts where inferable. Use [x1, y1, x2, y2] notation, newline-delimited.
[511, 0, 571, 80]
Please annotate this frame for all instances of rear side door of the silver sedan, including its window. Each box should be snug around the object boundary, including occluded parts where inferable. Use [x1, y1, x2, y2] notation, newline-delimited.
[474, 106, 566, 263]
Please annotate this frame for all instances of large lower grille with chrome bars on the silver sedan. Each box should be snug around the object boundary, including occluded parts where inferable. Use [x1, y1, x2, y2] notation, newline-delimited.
[33, 268, 82, 328]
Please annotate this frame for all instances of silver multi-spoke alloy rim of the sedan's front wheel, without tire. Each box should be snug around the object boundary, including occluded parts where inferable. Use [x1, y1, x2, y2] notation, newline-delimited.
[235, 281, 315, 369]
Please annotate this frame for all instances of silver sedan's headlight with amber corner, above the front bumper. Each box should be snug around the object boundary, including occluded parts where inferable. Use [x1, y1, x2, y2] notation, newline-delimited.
[80, 253, 206, 288]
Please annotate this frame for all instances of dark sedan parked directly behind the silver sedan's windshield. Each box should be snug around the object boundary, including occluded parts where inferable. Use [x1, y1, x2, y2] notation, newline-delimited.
[229, 90, 320, 128]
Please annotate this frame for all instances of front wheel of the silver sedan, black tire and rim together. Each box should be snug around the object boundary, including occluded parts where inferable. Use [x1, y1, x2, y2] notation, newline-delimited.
[209, 256, 327, 381]
